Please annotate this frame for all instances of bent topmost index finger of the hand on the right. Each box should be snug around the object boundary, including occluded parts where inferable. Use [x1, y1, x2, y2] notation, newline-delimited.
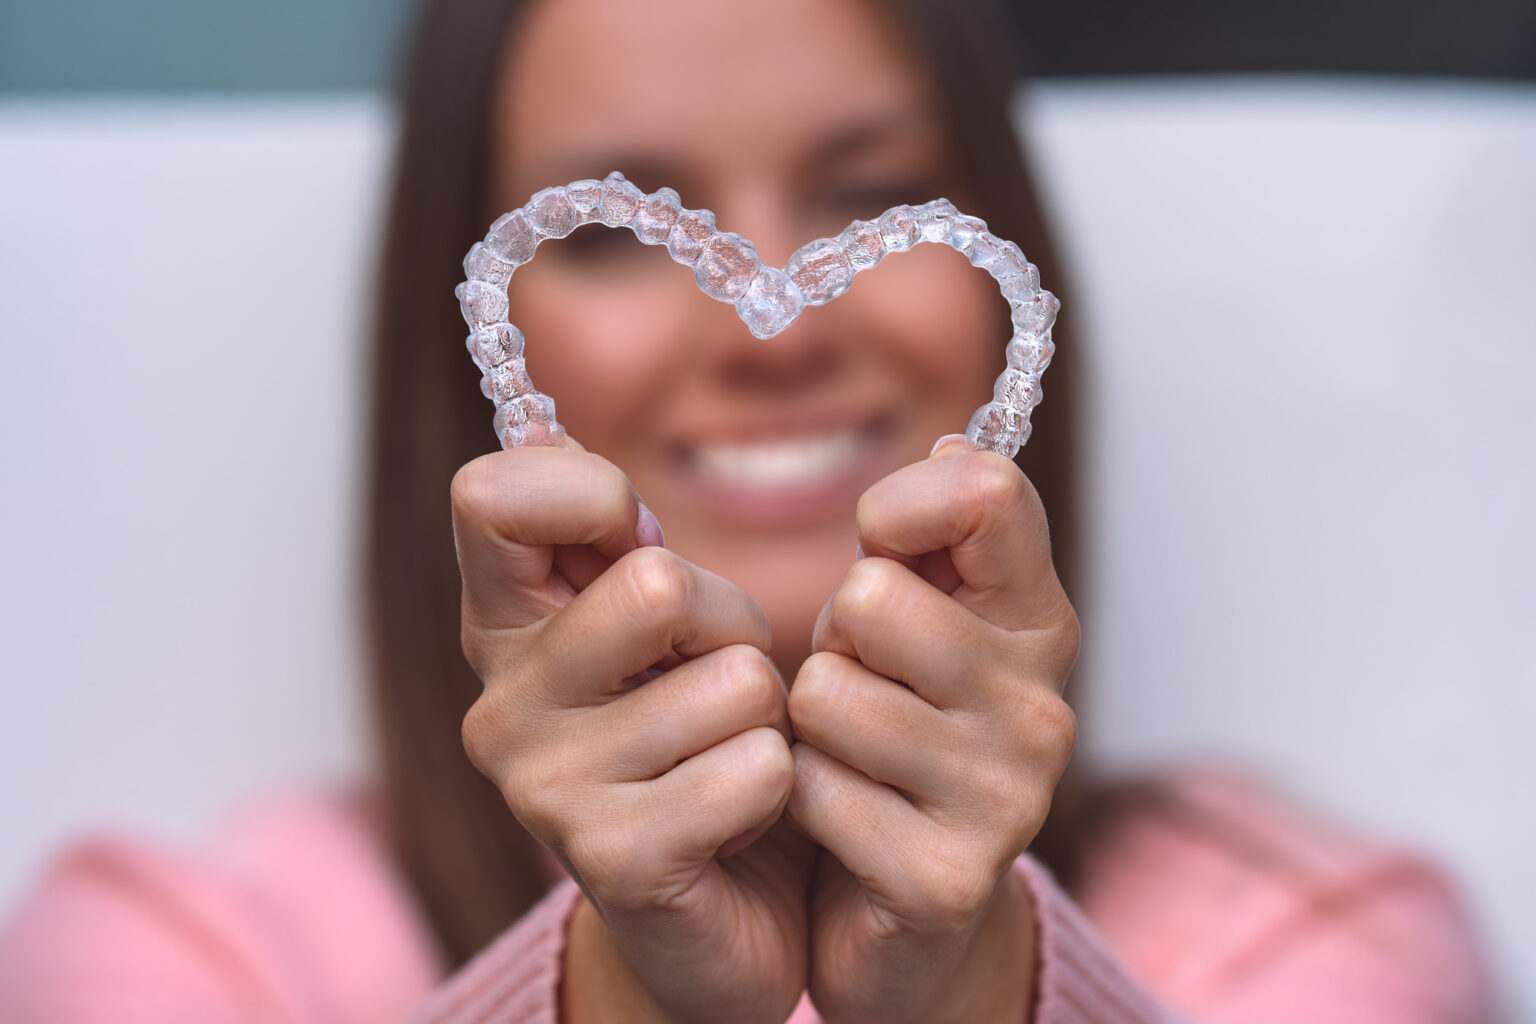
[856, 445, 1066, 629]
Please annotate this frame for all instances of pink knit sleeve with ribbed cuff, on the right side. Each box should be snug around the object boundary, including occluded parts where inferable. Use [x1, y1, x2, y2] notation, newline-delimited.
[1017, 855, 1496, 1024]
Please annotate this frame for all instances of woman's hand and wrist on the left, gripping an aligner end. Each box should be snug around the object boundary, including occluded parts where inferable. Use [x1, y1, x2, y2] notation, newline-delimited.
[453, 444, 811, 1021]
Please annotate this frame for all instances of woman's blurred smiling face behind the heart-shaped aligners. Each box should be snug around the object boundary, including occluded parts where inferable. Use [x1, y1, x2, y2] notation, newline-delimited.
[487, 0, 1006, 672]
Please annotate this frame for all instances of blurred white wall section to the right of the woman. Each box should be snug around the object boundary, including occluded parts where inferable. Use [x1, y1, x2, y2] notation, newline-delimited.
[1026, 81, 1536, 1018]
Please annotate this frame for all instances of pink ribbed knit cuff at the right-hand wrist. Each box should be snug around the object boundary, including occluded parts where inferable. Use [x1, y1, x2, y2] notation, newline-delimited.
[1014, 855, 1178, 1024]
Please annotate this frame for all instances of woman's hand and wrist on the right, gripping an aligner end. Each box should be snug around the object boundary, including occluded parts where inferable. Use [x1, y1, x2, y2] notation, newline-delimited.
[790, 442, 1078, 1022]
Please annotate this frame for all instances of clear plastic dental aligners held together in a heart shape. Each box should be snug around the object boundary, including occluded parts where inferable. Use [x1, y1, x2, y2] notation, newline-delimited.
[453, 170, 1060, 459]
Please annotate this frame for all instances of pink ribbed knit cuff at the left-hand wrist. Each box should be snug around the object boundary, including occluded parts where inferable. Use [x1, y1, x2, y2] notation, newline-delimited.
[415, 881, 581, 1024]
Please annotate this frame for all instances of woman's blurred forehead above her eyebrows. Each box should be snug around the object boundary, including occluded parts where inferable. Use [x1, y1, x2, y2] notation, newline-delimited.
[498, 0, 937, 187]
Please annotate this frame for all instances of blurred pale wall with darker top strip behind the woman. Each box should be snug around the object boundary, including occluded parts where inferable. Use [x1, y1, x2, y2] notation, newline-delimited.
[0, 0, 1536, 1019]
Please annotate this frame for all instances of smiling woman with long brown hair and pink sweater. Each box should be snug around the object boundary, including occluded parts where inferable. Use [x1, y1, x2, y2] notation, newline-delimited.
[0, 0, 1485, 1021]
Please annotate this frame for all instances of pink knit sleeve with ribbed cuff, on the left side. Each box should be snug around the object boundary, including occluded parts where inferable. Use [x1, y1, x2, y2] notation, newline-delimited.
[0, 798, 579, 1024]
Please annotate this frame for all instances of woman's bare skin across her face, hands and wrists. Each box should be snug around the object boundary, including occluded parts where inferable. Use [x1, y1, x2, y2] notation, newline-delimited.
[453, 0, 1077, 1021]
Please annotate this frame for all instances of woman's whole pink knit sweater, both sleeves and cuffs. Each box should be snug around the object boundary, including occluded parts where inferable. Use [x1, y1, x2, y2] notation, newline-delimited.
[0, 778, 1493, 1024]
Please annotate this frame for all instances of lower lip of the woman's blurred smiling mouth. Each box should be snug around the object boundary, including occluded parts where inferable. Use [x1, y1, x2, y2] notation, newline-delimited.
[677, 428, 899, 528]
